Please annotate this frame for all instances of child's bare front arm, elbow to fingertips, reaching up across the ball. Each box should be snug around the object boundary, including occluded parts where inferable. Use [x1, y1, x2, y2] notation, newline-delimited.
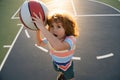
[33, 14, 70, 51]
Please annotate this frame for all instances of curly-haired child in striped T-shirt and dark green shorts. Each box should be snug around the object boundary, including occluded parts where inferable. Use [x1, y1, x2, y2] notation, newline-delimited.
[33, 12, 79, 80]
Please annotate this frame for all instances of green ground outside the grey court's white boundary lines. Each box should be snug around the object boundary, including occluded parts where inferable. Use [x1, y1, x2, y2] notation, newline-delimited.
[0, 0, 120, 64]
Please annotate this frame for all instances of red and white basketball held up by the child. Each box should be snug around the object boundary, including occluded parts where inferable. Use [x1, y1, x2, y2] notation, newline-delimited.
[19, 0, 48, 30]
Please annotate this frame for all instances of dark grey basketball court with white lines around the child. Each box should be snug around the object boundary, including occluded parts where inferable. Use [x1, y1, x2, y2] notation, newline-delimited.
[0, 0, 120, 80]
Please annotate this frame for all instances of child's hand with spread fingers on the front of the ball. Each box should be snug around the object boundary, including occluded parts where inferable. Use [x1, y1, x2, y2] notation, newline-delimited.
[32, 13, 44, 29]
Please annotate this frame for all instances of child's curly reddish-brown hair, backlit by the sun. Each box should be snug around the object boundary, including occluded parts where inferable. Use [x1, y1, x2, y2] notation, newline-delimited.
[47, 13, 79, 37]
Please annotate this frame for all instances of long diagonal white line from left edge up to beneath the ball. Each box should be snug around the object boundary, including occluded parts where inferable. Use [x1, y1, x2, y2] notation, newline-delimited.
[0, 24, 23, 71]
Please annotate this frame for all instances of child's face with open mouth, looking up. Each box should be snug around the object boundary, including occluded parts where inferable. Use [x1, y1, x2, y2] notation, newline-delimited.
[50, 22, 66, 40]
